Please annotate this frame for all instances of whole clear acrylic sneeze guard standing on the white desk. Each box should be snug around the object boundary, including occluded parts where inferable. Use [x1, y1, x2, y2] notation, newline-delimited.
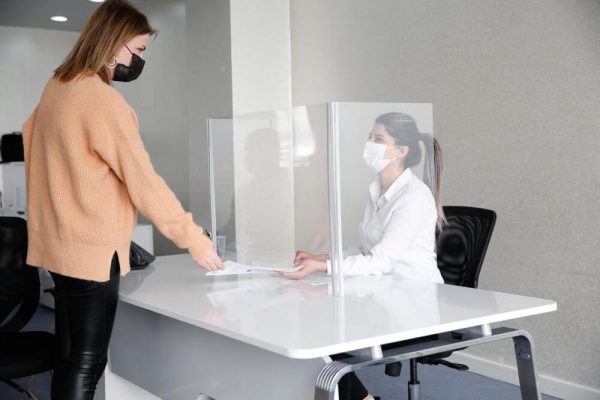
[208, 103, 433, 296]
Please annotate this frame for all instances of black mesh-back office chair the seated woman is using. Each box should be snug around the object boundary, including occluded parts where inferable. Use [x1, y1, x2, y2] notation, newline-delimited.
[385, 206, 496, 400]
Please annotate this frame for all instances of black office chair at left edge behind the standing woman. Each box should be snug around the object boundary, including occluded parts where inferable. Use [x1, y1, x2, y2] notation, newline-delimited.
[0, 217, 56, 399]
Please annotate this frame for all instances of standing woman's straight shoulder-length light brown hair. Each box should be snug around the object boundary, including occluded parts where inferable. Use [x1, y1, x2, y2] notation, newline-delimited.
[54, 0, 156, 83]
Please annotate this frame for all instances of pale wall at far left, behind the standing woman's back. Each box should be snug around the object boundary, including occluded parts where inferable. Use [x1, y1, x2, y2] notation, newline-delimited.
[0, 26, 79, 134]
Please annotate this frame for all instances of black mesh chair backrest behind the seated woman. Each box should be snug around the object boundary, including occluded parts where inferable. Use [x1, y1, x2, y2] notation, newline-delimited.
[436, 206, 496, 288]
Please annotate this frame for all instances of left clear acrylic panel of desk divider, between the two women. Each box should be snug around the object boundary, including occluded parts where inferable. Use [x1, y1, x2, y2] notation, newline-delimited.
[209, 105, 329, 267]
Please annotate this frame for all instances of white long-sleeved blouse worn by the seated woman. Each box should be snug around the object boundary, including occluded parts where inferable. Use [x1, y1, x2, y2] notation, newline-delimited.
[327, 168, 444, 283]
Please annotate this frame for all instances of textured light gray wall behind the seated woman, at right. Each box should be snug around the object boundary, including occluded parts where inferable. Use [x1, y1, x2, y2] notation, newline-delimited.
[290, 0, 600, 394]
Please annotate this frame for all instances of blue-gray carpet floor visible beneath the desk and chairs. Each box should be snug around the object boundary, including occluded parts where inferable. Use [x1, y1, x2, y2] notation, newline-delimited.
[0, 306, 560, 400]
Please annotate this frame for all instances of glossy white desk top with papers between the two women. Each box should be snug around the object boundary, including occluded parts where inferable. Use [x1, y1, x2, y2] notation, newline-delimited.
[120, 254, 556, 358]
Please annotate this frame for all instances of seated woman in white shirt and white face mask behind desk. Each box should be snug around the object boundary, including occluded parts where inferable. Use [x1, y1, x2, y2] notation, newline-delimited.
[282, 112, 444, 400]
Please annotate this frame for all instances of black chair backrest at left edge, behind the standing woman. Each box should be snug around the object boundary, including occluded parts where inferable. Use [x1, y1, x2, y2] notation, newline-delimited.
[0, 217, 40, 332]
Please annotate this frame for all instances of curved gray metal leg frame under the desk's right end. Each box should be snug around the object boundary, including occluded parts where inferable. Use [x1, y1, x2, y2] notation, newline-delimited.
[314, 327, 541, 400]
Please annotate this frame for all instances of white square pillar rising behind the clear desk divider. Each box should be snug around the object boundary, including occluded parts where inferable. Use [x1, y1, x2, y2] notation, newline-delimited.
[229, 0, 295, 265]
